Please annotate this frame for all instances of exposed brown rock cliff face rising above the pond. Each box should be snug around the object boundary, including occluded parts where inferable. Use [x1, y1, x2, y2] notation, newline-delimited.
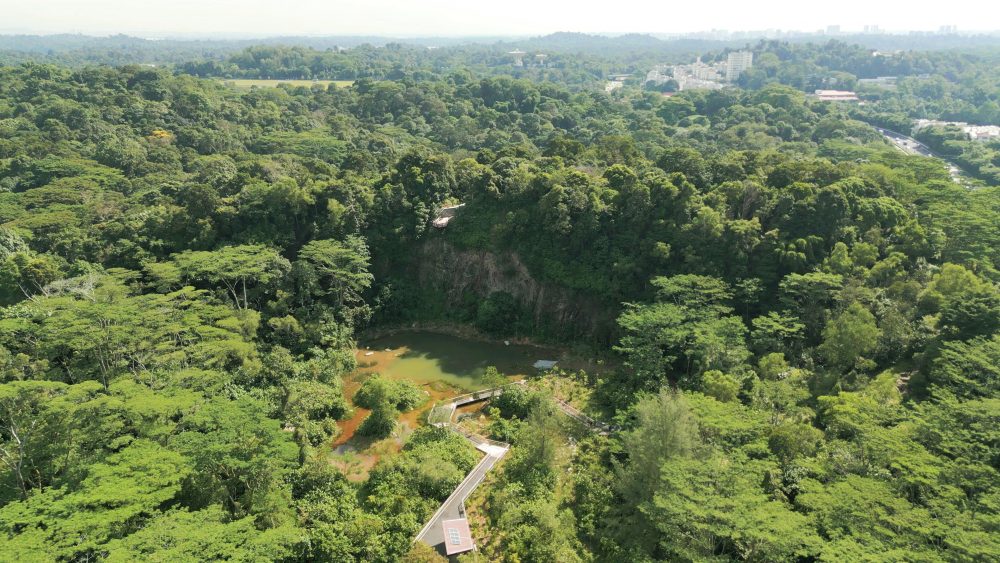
[415, 238, 616, 342]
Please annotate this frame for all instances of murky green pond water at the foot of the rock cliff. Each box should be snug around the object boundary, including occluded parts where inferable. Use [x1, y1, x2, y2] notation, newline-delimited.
[358, 330, 556, 391]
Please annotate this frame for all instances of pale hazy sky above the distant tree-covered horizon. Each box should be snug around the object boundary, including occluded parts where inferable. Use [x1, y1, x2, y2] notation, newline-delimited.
[0, 0, 1000, 37]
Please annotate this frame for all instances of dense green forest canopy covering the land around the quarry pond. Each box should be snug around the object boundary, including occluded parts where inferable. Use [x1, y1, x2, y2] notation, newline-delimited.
[0, 32, 1000, 562]
